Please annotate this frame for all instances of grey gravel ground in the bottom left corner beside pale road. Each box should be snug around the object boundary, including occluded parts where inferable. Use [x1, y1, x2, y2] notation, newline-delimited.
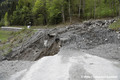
[0, 61, 34, 80]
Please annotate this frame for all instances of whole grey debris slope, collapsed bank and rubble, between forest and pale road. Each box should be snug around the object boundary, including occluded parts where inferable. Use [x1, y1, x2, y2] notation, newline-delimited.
[3, 19, 120, 61]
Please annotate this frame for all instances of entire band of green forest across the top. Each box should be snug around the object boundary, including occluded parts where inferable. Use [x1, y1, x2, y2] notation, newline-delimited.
[0, 0, 120, 26]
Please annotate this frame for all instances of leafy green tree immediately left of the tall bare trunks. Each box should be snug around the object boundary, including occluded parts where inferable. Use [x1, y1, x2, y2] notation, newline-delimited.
[47, 0, 66, 24]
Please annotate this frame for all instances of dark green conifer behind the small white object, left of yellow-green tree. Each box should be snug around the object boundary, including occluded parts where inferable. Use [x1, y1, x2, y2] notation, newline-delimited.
[10, 0, 33, 25]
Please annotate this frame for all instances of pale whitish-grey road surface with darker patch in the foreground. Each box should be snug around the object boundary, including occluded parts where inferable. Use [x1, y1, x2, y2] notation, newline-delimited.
[10, 49, 120, 80]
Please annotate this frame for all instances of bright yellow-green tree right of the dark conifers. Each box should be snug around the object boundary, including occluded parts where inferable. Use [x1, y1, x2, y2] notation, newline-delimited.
[32, 0, 47, 25]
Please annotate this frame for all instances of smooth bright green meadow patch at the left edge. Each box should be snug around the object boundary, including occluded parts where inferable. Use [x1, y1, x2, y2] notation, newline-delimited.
[0, 30, 11, 42]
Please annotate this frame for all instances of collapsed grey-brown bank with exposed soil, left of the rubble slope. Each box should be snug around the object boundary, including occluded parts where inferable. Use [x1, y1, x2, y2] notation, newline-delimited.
[6, 30, 60, 61]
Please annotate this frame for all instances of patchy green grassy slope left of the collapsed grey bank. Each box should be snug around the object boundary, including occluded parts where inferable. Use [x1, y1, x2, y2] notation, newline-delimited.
[0, 29, 35, 56]
